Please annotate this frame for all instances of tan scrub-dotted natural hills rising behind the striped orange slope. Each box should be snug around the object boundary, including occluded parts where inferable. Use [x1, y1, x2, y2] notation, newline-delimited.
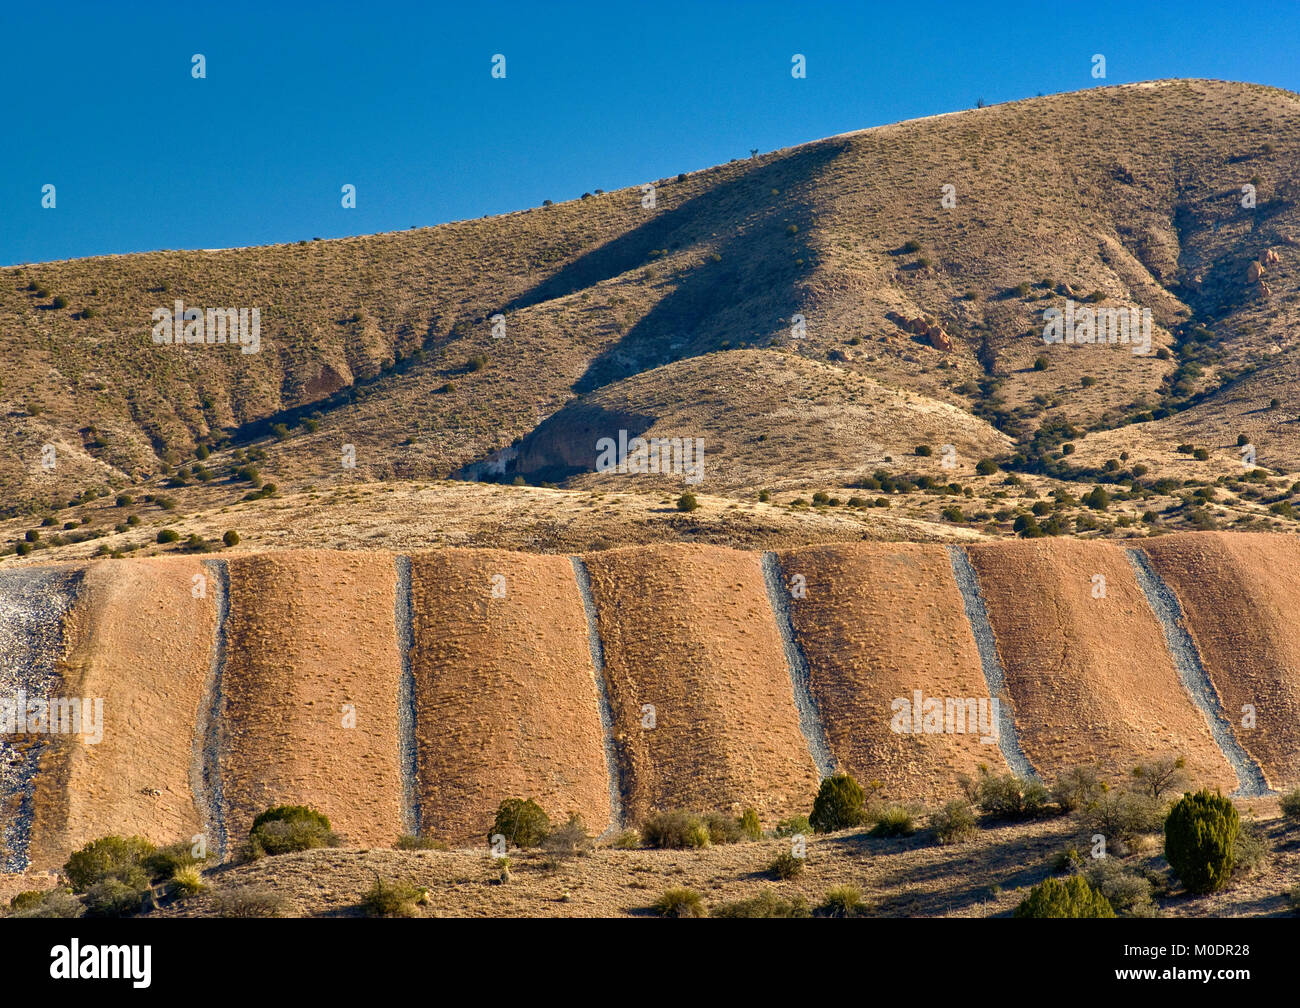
[0, 81, 1300, 563]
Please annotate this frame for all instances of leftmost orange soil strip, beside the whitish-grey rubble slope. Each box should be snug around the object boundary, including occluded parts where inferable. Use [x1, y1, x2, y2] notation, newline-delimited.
[30, 558, 216, 869]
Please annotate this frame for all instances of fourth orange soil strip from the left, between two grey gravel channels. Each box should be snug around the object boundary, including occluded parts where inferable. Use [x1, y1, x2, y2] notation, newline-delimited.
[585, 546, 818, 822]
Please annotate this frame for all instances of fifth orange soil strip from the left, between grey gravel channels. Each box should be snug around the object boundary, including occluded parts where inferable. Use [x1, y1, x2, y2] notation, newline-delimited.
[780, 542, 1006, 801]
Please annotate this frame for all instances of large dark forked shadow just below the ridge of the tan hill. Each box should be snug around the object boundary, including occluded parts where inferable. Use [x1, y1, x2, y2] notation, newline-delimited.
[507, 143, 848, 394]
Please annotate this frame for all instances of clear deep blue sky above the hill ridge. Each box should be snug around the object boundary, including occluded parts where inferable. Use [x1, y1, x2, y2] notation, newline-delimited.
[0, 0, 1300, 264]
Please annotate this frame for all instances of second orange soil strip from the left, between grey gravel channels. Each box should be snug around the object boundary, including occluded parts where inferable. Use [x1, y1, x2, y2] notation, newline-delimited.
[221, 550, 402, 851]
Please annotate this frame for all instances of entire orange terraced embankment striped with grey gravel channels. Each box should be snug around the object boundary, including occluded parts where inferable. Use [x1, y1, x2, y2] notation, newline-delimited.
[0, 533, 1300, 875]
